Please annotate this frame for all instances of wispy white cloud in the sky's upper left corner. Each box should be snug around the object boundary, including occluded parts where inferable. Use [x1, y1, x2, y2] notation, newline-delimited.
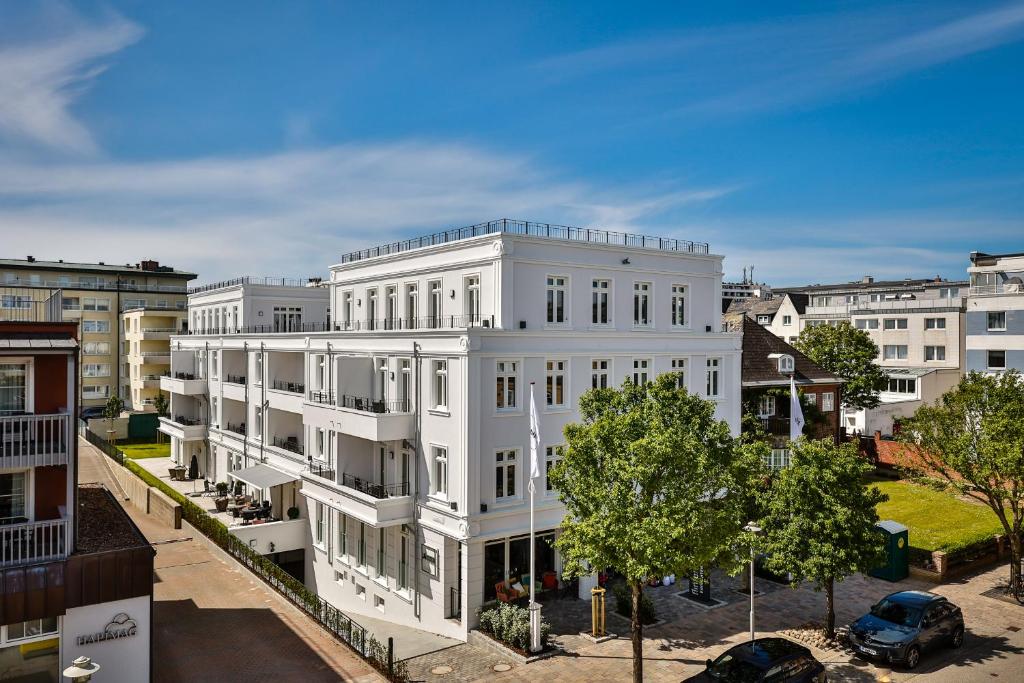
[0, 5, 142, 153]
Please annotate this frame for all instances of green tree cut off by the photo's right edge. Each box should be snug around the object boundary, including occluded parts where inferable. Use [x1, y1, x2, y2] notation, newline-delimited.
[899, 370, 1024, 591]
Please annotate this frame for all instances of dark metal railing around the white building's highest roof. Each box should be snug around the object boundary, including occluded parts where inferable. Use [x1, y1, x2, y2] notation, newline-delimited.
[341, 218, 709, 263]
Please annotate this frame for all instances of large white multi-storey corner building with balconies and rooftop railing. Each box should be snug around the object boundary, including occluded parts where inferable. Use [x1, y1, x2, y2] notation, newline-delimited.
[161, 221, 740, 640]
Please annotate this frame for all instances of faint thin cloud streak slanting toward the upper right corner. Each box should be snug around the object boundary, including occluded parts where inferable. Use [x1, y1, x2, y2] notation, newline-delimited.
[534, 2, 1024, 117]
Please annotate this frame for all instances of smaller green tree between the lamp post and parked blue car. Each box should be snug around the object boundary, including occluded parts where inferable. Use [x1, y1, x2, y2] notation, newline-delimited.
[761, 439, 888, 639]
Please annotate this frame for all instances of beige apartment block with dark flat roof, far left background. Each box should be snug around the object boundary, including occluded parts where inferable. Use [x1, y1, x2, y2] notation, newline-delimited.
[0, 256, 196, 408]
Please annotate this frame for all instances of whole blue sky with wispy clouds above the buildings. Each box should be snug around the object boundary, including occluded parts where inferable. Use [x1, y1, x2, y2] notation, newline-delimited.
[0, 0, 1024, 286]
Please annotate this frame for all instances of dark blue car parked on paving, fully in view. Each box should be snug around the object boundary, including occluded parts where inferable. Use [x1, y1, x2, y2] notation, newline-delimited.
[850, 591, 964, 669]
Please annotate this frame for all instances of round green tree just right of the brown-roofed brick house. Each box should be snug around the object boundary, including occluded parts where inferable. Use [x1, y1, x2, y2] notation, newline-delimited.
[794, 321, 888, 410]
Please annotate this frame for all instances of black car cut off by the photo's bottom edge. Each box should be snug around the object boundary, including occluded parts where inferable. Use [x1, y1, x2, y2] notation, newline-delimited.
[686, 638, 825, 683]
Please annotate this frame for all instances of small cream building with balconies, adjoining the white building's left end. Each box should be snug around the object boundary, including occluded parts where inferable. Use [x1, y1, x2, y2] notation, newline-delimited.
[121, 306, 188, 412]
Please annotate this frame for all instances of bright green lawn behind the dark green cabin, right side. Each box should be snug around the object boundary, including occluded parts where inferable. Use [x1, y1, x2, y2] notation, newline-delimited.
[869, 480, 1002, 551]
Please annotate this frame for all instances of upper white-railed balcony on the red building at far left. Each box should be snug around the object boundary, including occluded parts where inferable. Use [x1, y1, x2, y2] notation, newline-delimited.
[0, 414, 73, 468]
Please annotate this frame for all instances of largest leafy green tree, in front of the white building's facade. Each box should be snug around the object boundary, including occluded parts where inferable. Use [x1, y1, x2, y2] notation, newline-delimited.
[550, 374, 754, 683]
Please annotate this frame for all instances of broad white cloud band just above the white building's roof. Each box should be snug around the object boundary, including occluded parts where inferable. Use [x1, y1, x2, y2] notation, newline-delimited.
[0, 141, 732, 279]
